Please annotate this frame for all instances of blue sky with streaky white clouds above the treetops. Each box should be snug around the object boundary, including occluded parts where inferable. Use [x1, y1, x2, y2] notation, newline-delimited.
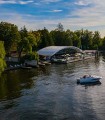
[0, 0, 105, 37]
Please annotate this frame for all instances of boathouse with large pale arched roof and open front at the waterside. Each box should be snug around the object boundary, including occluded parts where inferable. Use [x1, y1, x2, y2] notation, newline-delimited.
[38, 46, 83, 60]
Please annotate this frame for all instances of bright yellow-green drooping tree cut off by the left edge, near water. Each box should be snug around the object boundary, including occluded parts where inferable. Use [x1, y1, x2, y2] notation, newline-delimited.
[0, 41, 6, 73]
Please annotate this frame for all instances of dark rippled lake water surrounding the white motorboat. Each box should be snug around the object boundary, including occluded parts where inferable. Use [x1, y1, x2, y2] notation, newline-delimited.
[0, 56, 105, 120]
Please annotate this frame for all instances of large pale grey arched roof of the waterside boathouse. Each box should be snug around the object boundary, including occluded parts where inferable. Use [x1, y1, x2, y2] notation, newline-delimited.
[37, 46, 82, 56]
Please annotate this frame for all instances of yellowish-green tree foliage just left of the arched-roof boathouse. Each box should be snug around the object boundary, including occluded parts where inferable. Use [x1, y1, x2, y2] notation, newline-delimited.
[17, 27, 40, 59]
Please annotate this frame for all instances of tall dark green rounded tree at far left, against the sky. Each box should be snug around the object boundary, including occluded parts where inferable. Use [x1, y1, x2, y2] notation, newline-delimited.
[0, 22, 20, 53]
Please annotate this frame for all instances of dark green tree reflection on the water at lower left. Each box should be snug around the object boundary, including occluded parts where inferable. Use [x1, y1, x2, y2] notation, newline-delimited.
[0, 70, 33, 100]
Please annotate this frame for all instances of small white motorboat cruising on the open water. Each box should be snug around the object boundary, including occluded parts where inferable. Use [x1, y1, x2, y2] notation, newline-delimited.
[77, 75, 102, 84]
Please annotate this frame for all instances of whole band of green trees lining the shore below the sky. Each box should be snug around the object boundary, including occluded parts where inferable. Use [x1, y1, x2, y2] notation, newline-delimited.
[0, 22, 105, 71]
